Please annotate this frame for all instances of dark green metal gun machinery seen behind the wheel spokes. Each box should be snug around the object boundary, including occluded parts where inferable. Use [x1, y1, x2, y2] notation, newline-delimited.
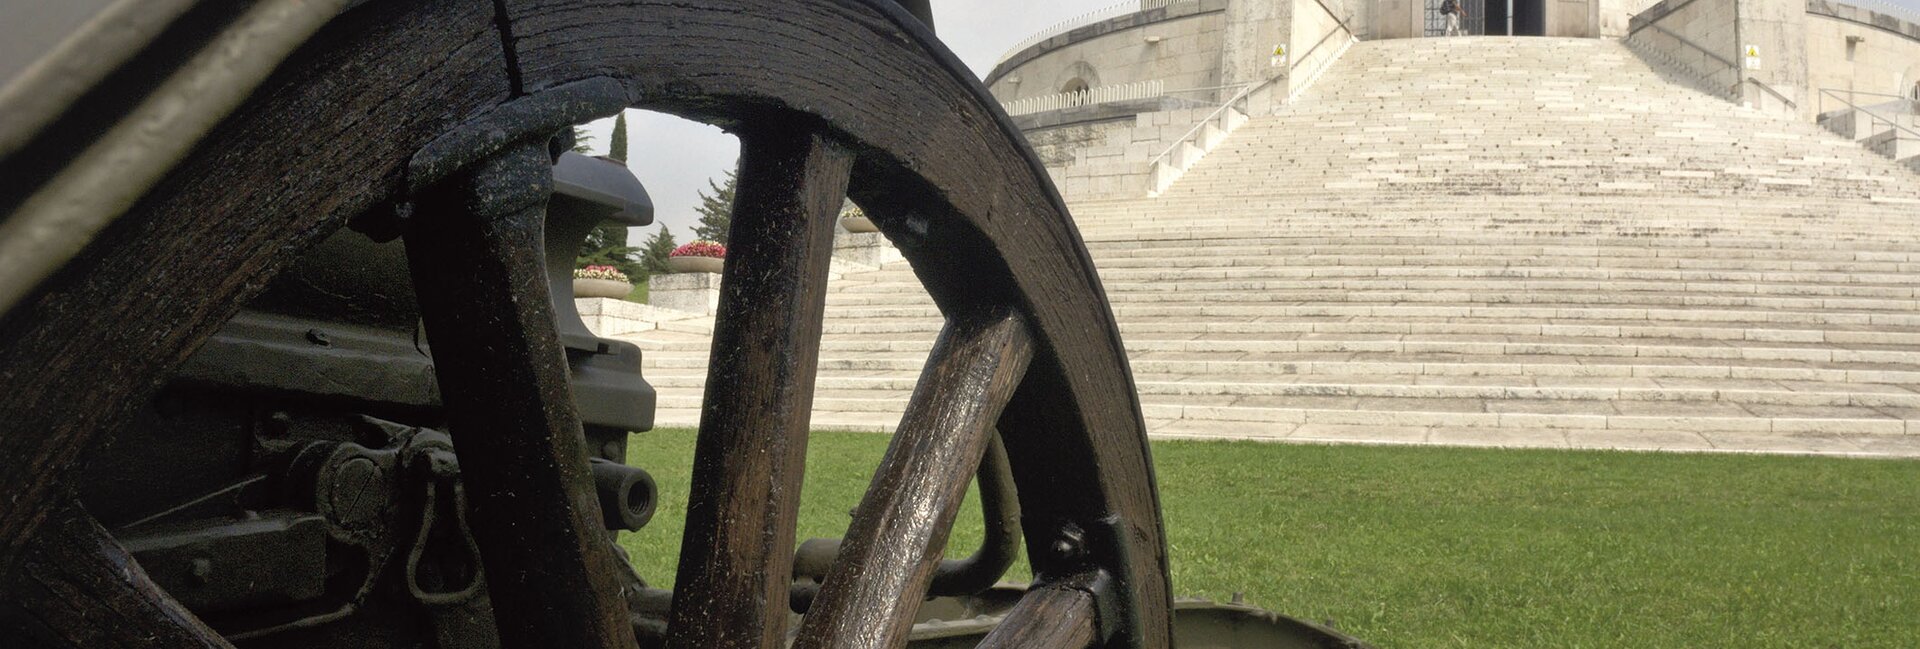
[56, 154, 657, 647]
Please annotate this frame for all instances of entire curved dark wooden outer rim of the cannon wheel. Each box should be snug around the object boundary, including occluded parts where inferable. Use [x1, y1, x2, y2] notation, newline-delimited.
[0, 0, 1171, 647]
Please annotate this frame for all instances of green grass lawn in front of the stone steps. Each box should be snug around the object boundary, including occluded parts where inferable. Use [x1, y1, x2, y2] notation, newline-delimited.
[622, 430, 1920, 647]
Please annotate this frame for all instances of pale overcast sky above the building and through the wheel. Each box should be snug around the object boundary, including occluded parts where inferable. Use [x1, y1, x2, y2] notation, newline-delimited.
[572, 0, 1117, 246]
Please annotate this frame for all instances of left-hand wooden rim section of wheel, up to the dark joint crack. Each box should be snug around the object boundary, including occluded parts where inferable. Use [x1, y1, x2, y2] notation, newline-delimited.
[0, 0, 509, 579]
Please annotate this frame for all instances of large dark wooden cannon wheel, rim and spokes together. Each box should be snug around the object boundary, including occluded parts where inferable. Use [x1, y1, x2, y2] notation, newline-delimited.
[0, 0, 1171, 647]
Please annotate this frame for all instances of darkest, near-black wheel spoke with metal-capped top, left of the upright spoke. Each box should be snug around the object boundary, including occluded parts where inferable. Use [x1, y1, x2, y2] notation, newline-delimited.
[407, 142, 634, 649]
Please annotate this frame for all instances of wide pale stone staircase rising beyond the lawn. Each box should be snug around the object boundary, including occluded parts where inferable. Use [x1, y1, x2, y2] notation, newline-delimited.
[606, 38, 1920, 455]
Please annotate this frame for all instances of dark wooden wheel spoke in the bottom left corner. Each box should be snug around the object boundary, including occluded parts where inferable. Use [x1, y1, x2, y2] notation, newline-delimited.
[0, 499, 232, 649]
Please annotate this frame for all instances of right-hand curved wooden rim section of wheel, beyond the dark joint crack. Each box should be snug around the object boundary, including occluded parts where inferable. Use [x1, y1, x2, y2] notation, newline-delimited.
[503, 0, 1171, 647]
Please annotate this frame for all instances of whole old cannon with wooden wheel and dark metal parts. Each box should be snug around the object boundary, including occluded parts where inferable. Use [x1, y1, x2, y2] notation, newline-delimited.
[0, 0, 1348, 647]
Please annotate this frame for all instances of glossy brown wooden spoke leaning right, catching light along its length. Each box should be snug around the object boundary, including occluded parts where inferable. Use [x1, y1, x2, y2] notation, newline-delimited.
[795, 311, 1033, 649]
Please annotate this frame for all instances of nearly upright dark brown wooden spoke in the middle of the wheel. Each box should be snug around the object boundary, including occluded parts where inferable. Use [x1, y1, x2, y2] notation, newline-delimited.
[668, 131, 852, 649]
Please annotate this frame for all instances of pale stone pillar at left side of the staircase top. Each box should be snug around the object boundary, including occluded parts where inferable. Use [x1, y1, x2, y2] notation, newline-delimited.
[1219, 0, 1300, 115]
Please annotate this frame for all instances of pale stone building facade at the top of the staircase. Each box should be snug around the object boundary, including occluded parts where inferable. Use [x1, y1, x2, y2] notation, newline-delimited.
[985, 0, 1920, 196]
